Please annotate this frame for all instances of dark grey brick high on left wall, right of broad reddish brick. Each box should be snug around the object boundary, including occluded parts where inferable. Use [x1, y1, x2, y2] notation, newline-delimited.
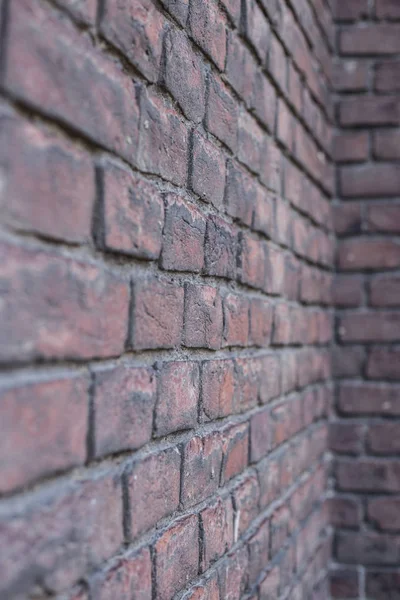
[164, 28, 206, 123]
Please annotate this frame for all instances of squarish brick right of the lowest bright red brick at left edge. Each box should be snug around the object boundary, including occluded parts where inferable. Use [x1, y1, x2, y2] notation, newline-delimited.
[93, 364, 156, 457]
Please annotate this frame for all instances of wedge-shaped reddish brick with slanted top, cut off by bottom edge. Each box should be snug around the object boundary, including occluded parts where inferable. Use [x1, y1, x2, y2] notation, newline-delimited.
[89, 548, 152, 600]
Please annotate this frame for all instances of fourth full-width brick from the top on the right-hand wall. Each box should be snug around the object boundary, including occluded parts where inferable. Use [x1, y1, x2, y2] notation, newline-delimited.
[338, 238, 400, 271]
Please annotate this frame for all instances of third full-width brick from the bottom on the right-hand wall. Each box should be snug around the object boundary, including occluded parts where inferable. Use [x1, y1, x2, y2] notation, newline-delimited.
[338, 382, 400, 416]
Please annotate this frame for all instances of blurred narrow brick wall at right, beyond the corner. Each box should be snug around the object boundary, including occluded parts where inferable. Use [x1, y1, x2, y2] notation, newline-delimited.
[330, 0, 400, 600]
